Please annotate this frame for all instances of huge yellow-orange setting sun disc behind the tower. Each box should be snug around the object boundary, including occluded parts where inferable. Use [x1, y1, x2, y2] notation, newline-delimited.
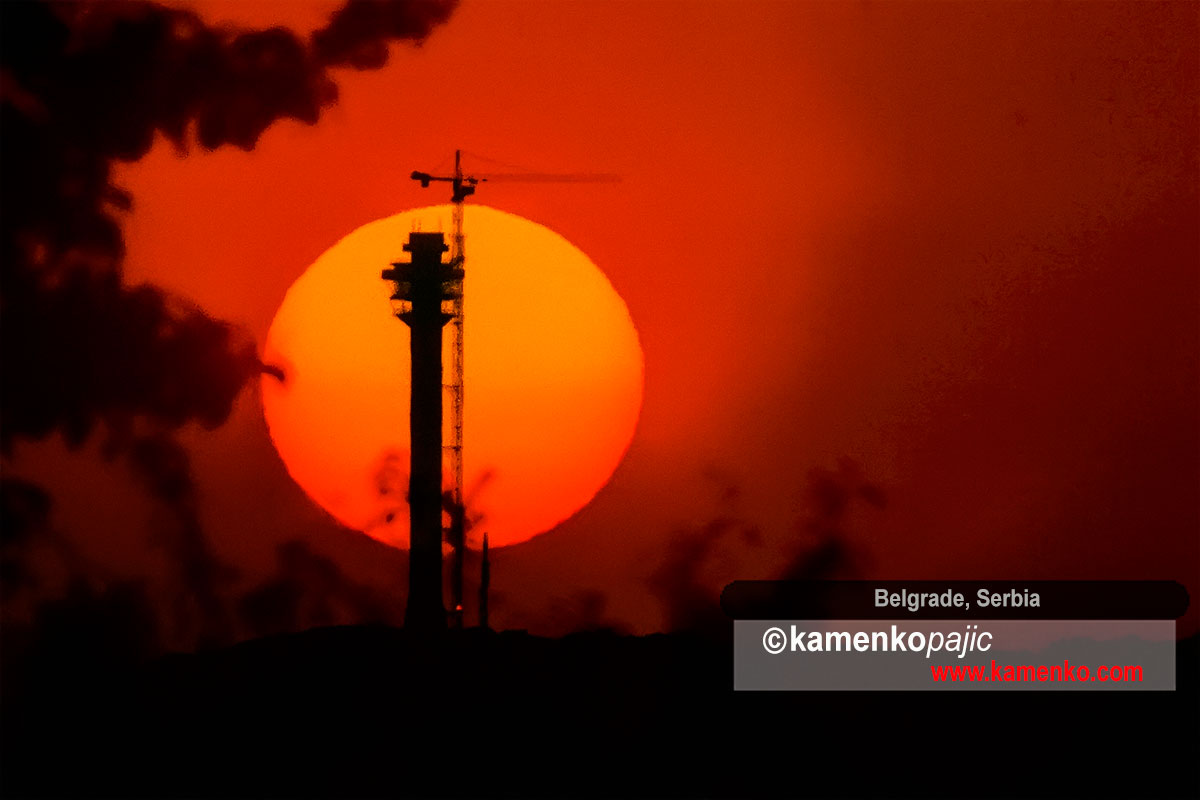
[262, 205, 643, 548]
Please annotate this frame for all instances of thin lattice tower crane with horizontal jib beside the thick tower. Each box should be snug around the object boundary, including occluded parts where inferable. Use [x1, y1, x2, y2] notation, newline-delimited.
[412, 150, 620, 627]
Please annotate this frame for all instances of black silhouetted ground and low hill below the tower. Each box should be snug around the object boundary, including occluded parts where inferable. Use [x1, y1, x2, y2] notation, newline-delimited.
[0, 626, 1200, 798]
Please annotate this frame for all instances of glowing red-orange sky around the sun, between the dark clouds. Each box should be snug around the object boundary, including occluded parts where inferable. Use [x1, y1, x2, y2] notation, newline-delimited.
[13, 0, 1200, 631]
